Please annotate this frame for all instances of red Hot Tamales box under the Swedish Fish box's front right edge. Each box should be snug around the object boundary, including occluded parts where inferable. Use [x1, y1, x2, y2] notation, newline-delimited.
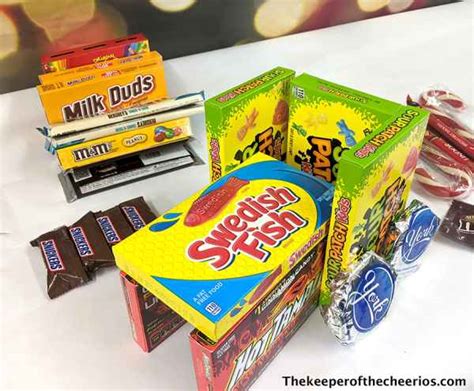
[189, 242, 325, 391]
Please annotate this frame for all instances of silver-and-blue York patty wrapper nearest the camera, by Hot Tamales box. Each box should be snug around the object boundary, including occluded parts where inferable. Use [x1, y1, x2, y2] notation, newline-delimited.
[321, 251, 396, 345]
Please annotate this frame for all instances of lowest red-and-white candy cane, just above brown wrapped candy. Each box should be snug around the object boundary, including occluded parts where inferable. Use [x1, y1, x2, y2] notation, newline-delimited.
[415, 151, 472, 198]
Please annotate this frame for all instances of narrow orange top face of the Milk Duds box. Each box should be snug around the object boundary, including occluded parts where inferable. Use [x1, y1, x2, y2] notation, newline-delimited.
[38, 51, 163, 87]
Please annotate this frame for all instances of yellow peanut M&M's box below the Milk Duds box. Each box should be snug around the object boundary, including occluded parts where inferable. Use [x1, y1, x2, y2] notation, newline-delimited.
[56, 117, 192, 171]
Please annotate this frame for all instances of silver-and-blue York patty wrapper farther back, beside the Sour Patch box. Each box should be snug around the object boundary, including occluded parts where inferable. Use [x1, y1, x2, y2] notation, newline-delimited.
[381, 200, 440, 277]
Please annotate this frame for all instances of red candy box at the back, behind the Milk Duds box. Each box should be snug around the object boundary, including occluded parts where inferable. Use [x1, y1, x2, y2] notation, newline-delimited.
[41, 34, 150, 73]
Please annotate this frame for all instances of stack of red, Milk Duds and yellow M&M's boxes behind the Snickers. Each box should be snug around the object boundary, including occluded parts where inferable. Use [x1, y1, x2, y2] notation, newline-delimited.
[37, 34, 199, 201]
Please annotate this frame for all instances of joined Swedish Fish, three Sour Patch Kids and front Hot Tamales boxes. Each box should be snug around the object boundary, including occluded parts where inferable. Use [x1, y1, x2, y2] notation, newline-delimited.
[114, 67, 428, 390]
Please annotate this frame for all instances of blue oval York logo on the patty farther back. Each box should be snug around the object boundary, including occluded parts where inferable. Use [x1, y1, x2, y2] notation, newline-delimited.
[401, 207, 439, 264]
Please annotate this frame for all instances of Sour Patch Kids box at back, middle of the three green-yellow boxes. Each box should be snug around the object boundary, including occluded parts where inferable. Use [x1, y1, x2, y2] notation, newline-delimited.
[287, 73, 400, 183]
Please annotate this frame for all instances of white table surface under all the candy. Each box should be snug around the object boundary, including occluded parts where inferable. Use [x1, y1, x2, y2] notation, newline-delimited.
[0, 1, 474, 390]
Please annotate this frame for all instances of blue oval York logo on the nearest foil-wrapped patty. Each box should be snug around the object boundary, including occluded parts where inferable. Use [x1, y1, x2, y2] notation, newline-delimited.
[348, 262, 395, 333]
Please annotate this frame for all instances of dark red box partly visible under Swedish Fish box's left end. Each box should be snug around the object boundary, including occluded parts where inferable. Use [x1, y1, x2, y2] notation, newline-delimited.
[120, 272, 186, 352]
